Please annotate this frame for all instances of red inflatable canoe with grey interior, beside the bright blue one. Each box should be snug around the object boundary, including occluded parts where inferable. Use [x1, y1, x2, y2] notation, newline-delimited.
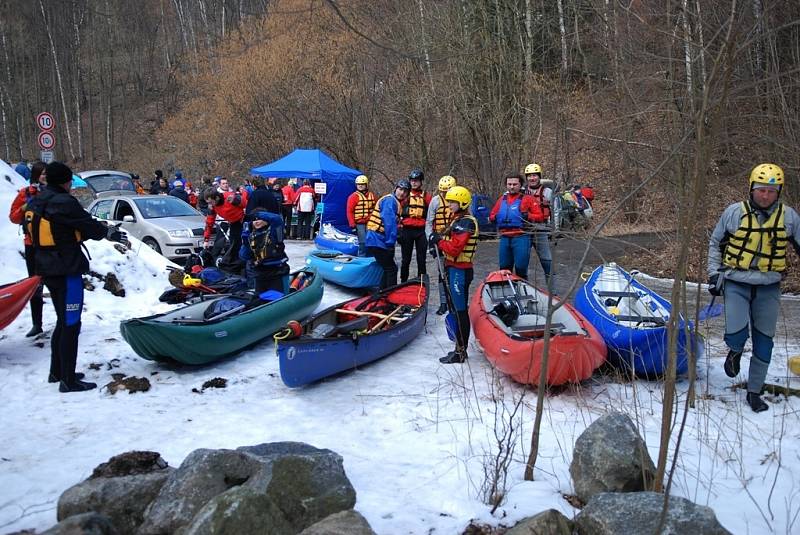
[469, 269, 606, 386]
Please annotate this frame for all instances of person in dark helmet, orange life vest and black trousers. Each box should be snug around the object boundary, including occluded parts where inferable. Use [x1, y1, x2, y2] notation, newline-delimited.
[397, 169, 431, 282]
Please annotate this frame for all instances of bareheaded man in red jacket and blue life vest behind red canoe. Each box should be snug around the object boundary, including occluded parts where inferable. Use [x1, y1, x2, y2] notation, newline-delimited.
[489, 175, 545, 279]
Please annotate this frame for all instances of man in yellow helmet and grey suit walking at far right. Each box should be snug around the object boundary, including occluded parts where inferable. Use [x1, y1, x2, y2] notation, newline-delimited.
[708, 163, 800, 412]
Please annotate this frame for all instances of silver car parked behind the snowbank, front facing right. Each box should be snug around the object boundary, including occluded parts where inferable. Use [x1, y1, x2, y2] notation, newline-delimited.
[89, 194, 205, 259]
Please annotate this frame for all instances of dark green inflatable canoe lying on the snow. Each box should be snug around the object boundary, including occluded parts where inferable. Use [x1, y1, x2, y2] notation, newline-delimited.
[120, 269, 323, 365]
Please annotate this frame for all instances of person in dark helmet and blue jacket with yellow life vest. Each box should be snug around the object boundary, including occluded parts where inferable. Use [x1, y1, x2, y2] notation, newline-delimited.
[364, 179, 411, 290]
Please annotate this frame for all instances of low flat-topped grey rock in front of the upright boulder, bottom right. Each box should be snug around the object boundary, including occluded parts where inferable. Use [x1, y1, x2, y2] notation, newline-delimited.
[575, 492, 729, 535]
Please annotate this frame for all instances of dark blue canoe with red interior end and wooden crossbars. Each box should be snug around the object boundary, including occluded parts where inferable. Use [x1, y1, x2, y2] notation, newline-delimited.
[275, 277, 428, 387]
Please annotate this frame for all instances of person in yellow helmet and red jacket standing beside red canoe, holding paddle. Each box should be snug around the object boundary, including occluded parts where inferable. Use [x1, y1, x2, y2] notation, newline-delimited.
[431, 186, 478, 364]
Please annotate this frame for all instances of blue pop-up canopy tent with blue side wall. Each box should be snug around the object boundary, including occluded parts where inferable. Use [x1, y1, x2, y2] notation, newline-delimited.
[250, 149, 361, 232]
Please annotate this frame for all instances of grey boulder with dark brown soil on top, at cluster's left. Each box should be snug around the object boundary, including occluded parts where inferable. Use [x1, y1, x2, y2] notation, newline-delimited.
[57, 468, 174, 534]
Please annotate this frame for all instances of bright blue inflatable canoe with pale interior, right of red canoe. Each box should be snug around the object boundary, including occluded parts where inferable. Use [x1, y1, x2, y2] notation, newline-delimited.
[575, 262, 694, 377]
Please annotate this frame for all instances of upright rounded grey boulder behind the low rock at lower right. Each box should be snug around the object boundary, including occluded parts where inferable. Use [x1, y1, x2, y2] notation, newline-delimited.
[569, 413, 656, 502]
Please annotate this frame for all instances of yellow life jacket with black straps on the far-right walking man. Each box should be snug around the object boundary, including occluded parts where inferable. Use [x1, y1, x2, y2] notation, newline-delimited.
[722, 202, 788, 272]
